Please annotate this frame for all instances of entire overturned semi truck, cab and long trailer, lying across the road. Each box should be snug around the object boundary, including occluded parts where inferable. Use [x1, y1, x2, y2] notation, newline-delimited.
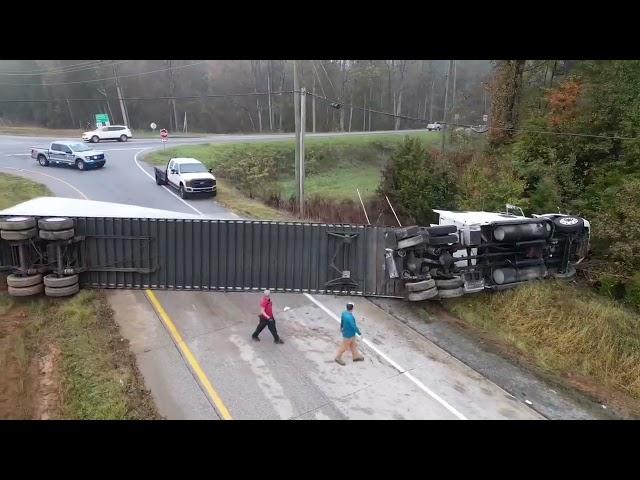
[0, 197, 590, 301]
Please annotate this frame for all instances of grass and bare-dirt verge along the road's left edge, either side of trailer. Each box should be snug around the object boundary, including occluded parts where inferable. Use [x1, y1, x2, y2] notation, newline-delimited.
[0, 174, 158, 419]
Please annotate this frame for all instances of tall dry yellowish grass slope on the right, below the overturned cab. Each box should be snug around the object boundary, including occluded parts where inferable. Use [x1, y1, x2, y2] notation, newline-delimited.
[444, 280, 640, 415]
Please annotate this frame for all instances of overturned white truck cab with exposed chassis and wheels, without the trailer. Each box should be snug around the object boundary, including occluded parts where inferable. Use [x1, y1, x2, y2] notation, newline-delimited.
[385, 205, 591, 301]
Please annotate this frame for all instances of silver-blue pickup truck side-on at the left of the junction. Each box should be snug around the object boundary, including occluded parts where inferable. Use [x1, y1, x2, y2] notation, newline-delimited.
[31, 140, 107, 170]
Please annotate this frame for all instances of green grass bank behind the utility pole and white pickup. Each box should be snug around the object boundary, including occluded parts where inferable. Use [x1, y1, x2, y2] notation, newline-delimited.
[145, 132, 439, 201]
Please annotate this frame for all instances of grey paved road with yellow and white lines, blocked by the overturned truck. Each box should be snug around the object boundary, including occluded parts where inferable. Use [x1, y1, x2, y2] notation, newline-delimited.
[0, 131, 541, 419]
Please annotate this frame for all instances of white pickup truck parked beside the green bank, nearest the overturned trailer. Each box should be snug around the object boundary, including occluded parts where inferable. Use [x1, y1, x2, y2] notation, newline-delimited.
[154, 158, 217, 198]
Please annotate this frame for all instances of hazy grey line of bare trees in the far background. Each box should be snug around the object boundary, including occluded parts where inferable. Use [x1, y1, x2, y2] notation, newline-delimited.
[0, 60, 491, 133]
